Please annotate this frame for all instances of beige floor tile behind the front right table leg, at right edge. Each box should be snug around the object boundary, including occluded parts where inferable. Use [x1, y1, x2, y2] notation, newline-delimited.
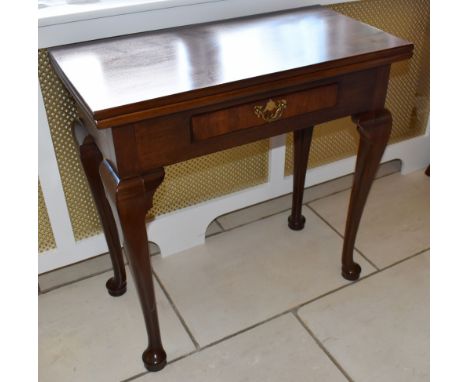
[310, 171, 429, 268]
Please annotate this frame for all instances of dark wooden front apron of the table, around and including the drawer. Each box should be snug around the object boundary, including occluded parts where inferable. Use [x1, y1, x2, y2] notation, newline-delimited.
[106, 66, 388, 177]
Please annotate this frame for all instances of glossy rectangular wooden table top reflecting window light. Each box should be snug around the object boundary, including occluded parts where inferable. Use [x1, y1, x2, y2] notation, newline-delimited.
[50, 7, 412, 128]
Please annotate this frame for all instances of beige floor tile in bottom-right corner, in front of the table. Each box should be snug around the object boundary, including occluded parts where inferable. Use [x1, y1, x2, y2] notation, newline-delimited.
[299, 253, 429, 382]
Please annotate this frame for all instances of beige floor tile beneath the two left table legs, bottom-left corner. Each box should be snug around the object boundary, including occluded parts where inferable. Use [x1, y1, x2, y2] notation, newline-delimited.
[39, 269, 194, 382]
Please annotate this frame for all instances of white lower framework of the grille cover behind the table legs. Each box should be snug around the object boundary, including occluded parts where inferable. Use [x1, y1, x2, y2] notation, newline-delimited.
[39, 130, 429, 273]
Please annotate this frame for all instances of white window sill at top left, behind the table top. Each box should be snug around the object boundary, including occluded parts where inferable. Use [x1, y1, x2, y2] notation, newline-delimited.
[38, 0, 356, 49]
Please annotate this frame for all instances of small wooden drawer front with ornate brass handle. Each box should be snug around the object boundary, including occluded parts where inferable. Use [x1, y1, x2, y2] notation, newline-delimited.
[191, 84, 338, 141]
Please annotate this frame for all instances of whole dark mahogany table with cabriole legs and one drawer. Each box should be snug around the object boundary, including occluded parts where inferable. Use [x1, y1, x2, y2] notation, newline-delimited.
[49, 7, 413, 371]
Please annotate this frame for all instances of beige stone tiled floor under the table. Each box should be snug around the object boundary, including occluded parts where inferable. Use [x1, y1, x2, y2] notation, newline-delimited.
[39, 167, 429, 382]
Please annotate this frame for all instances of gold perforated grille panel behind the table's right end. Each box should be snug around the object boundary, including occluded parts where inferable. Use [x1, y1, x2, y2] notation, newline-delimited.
[285, 0, 429, 175]
